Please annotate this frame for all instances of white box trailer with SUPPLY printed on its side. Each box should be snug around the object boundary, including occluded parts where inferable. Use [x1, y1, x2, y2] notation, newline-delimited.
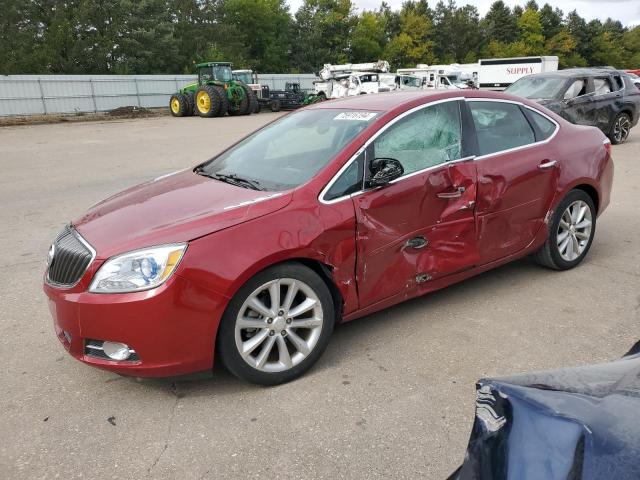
[477, 56, 558, 90]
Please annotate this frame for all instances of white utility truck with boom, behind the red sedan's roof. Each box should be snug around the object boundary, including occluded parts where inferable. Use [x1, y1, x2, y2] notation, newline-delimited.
[314, 60, 392, 98]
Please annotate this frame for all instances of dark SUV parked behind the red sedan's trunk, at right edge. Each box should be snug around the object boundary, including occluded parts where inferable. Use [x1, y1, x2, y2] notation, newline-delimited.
[505, 68, 640, 144]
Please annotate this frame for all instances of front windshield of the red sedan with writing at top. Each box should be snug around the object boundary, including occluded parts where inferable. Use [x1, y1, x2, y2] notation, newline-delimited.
[196, 109, 378, 191]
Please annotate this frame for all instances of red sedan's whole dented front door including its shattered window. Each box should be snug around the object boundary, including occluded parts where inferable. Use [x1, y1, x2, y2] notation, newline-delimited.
[353, 101, 479, 308]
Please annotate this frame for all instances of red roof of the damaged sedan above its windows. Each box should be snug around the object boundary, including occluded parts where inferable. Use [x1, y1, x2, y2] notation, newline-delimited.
[308, 89, 528, 112]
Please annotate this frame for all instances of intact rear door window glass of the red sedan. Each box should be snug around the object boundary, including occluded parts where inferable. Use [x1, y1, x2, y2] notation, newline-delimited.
[469, 101, 536, 155]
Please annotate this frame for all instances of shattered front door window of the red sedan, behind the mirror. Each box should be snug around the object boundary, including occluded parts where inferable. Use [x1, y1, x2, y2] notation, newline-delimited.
[373, 101, 462, 174]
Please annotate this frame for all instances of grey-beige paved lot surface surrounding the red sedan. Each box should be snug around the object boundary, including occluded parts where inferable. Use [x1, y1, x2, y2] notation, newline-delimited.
[0, 113, 640, 480]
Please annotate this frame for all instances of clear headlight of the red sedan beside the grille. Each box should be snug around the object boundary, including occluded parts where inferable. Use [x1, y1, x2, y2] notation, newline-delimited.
[89, 243, 187, 293]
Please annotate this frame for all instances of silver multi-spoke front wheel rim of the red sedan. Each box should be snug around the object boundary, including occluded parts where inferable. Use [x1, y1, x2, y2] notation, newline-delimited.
[235, 278, 324, 372]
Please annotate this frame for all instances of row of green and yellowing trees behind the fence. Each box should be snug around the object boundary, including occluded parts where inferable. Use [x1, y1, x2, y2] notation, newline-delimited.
[0, 0, 640, 74]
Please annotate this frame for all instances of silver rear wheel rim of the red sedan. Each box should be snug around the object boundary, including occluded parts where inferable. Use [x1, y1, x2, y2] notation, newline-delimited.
[556, 200, 593, 262]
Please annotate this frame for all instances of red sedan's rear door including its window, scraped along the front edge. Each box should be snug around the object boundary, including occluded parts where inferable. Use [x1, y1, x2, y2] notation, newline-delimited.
[467, 99, 558, 264]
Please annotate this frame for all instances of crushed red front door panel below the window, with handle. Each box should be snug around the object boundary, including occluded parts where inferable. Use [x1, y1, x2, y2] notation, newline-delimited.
[353, 161, 478, 308]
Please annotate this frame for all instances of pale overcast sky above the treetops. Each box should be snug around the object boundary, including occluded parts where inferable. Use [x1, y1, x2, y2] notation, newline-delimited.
[288, 0, 640, 26]
